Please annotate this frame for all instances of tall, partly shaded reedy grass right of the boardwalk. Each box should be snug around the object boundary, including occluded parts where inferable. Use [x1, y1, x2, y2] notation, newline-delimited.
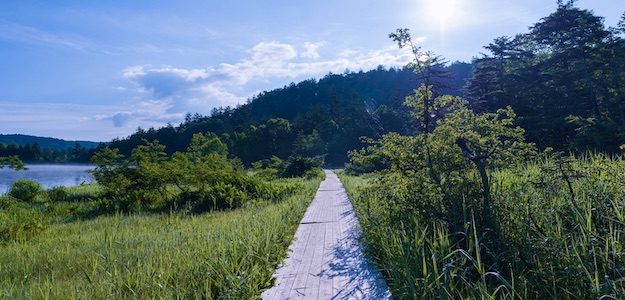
[340, 155, 625, 299]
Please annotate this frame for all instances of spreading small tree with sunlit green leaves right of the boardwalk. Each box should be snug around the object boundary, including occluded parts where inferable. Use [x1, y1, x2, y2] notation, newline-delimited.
[347, 91, 535, 222]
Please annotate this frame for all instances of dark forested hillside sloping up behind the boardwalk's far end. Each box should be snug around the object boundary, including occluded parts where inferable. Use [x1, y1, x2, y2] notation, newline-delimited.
[109, 63, 472, 165]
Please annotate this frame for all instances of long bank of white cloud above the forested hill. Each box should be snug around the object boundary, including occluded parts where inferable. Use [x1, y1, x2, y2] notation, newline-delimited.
[114, 41, 411, 127]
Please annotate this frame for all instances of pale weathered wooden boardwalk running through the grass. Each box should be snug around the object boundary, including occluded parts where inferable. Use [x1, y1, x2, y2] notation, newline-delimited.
[262, 171, 391, 300]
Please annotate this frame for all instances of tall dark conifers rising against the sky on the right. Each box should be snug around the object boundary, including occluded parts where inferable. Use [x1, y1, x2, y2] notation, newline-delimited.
[467, 1, 625, 153]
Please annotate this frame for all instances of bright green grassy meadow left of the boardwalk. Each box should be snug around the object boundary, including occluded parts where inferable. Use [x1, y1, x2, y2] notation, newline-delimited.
[0, 179, 319, 299]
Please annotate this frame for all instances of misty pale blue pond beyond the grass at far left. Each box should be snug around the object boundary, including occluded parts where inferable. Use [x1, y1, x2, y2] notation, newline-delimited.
[0, 164, 94, 194]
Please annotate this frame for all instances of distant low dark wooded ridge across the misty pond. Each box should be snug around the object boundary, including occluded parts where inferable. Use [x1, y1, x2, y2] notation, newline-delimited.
[0, 143, 95, 163]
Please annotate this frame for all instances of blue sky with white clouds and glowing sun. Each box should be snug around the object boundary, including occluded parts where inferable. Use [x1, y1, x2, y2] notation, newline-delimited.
[0, 0, 625, 141]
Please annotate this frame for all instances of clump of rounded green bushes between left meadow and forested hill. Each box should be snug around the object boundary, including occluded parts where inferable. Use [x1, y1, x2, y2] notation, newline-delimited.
[93, 134, 306, 212]
